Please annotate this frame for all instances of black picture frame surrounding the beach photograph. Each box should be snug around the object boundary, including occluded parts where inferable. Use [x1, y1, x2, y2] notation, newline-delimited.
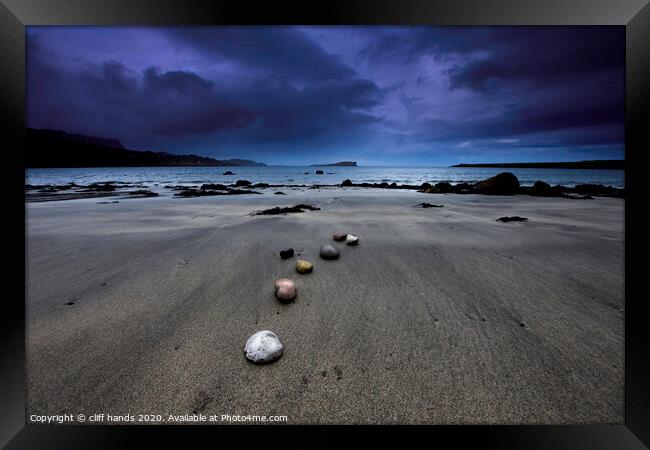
[0, 0, 650, 449]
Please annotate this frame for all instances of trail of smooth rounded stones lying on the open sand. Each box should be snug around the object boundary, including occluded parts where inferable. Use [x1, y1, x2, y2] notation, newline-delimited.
[244, 233, 359, 364]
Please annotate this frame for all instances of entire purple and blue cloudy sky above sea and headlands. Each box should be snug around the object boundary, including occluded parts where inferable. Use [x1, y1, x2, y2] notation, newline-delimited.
[27, 26, 625, 166]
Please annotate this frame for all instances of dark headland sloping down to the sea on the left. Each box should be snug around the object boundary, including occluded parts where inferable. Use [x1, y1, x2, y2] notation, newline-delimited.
[25, 128, 264, 168]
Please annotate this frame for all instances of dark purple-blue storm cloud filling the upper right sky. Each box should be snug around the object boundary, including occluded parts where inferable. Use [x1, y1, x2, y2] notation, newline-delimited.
[360, 27, 625, 156]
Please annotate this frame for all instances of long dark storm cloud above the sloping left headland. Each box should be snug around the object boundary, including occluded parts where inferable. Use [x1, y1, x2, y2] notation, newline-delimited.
[28, 28, 381, 151]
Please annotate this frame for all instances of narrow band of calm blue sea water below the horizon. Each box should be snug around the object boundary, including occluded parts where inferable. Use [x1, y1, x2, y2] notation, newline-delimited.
[25, 166, 625, 188]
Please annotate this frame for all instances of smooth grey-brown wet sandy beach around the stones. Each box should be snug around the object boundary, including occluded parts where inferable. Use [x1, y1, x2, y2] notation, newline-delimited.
[26, 188, 625, 424]
